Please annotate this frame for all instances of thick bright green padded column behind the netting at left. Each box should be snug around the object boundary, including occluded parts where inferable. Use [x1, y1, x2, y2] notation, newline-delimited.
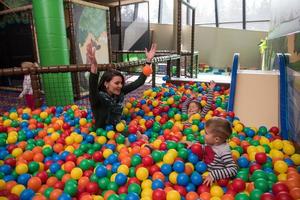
[32, 0, 74, 106]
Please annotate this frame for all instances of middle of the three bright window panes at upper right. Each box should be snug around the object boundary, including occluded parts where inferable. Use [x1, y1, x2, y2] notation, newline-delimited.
[218, 0, 243, 29]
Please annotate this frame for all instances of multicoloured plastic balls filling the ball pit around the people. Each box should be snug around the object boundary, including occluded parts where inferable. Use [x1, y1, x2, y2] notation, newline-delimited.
[0, 82, 300, 200]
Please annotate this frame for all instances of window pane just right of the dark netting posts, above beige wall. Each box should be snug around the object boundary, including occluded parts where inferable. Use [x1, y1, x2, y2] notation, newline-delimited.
[190, 0, 216, 26]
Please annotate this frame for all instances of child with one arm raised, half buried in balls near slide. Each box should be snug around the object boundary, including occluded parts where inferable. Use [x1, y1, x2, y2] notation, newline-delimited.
[182, 81, 216, 126]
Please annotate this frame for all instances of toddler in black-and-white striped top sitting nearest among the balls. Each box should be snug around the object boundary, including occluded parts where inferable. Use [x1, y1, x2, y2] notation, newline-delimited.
[190, 117, 238, 185]
